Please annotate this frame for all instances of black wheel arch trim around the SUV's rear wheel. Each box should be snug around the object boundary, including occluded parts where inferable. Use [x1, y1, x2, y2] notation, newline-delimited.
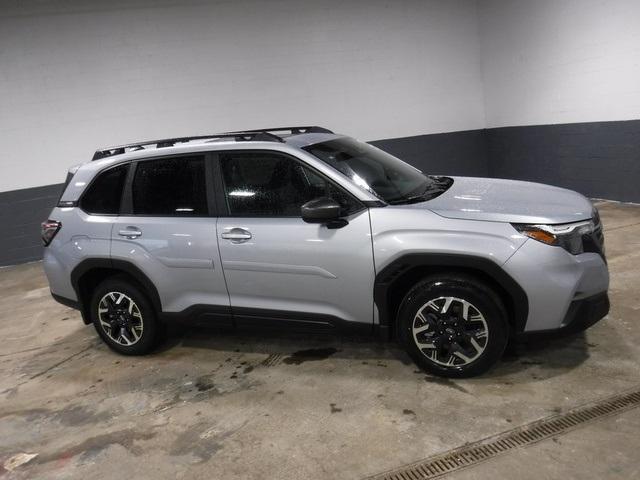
[71, 258, 162, 325]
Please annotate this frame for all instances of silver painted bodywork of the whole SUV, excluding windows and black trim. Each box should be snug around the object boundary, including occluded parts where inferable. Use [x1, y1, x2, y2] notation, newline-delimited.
[44, 134, 609, 331]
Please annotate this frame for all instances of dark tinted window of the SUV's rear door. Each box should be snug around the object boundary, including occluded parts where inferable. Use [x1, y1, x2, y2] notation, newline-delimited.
[131, 156, 207, 216]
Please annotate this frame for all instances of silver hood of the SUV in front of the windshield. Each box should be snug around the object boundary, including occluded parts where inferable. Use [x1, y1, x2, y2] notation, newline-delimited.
[416, 177, 593, 224]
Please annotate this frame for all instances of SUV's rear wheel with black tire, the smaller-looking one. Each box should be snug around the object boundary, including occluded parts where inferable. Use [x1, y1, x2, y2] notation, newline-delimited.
[89, 276, 162, 355]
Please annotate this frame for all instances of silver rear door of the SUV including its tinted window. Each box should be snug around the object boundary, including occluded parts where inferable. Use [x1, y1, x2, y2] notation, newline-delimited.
[111, 154, 229, 315]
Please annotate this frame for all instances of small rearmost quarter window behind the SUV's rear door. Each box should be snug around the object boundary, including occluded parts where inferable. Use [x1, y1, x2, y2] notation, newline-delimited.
[80, 164, 129, 215]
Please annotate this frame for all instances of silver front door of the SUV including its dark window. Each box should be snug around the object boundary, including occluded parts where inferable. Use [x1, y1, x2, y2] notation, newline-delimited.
[217, 151, 374, 325]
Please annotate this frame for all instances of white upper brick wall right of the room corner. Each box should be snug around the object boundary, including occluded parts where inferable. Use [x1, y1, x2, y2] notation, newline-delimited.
[478, 0, 640, 128]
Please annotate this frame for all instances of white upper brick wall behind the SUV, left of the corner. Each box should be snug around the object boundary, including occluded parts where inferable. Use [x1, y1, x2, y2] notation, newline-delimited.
[0, 0, 484, 191]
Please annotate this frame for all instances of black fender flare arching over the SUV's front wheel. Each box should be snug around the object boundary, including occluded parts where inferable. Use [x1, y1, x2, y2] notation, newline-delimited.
[373, 253, 529, 334]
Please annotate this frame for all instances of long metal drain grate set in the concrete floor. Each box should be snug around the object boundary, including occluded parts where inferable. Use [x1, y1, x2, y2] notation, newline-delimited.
[370, 390, 640, 480]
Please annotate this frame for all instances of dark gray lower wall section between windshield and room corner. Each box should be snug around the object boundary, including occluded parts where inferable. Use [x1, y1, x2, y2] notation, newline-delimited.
[371, 130, 489, 177]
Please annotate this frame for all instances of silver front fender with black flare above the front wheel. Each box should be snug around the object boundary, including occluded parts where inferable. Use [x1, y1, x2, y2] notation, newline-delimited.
[371, 207, 529, 332]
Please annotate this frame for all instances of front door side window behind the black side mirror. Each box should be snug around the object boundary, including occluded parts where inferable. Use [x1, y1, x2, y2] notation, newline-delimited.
[220, 152, 360, 217]
